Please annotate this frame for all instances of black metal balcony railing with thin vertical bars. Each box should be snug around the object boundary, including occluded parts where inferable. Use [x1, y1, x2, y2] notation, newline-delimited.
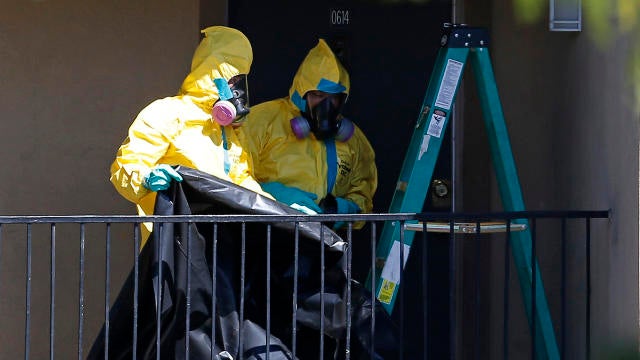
[0, 211, 609, 359]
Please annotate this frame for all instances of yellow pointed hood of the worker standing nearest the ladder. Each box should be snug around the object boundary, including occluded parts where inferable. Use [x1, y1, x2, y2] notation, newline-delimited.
[289, 39, 350, 112]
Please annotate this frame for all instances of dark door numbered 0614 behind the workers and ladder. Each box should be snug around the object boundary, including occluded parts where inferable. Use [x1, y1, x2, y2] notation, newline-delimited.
[229, 0, 452, 359]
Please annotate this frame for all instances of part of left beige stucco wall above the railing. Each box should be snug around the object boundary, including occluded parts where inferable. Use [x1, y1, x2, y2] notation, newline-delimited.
[0, 0, 198, 214]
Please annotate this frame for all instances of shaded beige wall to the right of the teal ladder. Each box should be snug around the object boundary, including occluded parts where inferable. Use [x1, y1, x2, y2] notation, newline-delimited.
[484, 0, 639, 358]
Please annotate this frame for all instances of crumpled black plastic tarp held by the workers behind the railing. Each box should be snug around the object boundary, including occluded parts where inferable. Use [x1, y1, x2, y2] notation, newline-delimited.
[87, 167, 397, 360]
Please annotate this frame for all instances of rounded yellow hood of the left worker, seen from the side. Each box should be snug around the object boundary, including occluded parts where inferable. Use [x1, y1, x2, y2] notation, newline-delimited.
[178, 26, 253, 112]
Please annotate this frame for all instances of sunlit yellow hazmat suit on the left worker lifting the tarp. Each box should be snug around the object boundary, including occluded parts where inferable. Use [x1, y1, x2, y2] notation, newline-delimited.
[110, 26, 271, 242]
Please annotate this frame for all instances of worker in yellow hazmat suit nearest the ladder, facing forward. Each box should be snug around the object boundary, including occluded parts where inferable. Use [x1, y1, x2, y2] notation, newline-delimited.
[237, 39, 378, 229]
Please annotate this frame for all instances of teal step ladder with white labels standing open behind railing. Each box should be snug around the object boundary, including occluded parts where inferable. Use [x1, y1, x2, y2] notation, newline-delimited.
[367, 24, 560, 359]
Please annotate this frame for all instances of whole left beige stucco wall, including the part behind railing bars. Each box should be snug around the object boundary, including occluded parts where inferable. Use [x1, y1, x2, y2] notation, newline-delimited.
[0, 0, 226, 359]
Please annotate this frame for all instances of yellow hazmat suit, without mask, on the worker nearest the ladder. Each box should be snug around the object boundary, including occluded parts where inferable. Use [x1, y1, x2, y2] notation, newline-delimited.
[237, 39, 378, 228]
